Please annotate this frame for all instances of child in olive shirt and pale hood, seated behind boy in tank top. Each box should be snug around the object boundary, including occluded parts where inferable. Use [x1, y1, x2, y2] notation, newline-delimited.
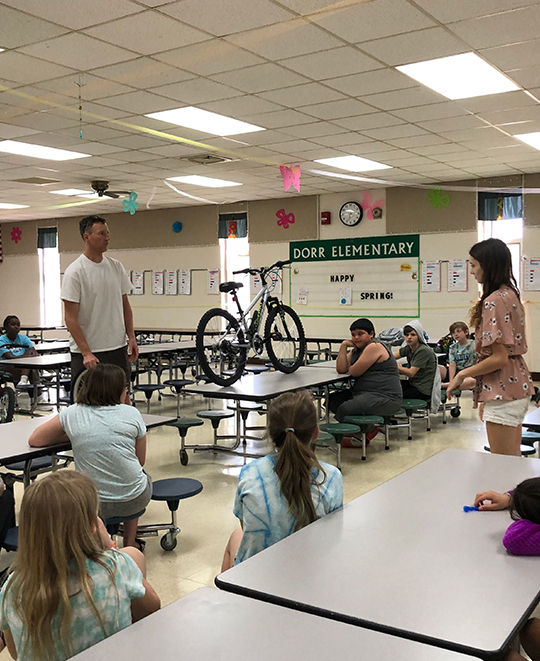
[394, 319, 441, 412]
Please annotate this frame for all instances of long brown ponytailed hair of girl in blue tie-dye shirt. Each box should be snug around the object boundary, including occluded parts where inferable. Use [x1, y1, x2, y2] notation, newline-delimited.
[268, 390, 326, 530]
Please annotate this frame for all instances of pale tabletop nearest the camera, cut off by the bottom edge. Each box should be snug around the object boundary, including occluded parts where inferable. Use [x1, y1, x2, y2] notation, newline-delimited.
[69, 588, 471, 661]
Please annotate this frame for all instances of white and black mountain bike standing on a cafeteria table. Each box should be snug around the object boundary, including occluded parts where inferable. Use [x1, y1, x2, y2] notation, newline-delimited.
[196, 260, 306, 386]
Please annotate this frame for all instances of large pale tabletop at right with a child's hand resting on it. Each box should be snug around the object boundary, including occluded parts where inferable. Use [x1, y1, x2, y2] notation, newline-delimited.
[216, 449, 540, 655]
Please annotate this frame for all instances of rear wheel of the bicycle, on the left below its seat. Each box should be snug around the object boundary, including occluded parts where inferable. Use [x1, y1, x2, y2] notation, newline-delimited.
[196, 308, 247, 386]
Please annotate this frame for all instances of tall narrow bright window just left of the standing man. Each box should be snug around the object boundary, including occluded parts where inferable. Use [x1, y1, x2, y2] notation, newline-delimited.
[38, 227, 62, 326]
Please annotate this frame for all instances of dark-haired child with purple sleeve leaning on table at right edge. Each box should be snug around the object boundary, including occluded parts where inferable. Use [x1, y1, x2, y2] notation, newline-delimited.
[474, 477, 540, 661]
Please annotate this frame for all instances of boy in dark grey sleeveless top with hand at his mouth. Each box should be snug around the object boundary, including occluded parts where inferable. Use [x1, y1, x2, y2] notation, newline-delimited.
[329, 318, 402, 422]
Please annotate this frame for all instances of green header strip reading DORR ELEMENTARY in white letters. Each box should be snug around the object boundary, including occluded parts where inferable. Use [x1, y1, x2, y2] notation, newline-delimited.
[289, 234, 420, 262]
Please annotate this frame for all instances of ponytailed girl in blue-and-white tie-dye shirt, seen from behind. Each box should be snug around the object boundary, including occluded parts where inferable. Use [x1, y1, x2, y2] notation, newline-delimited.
[221, 390, 343, 571]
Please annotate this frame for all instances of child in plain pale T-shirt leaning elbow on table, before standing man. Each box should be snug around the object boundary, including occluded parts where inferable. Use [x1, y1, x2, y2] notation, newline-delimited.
[28, 363, 152, 550]
